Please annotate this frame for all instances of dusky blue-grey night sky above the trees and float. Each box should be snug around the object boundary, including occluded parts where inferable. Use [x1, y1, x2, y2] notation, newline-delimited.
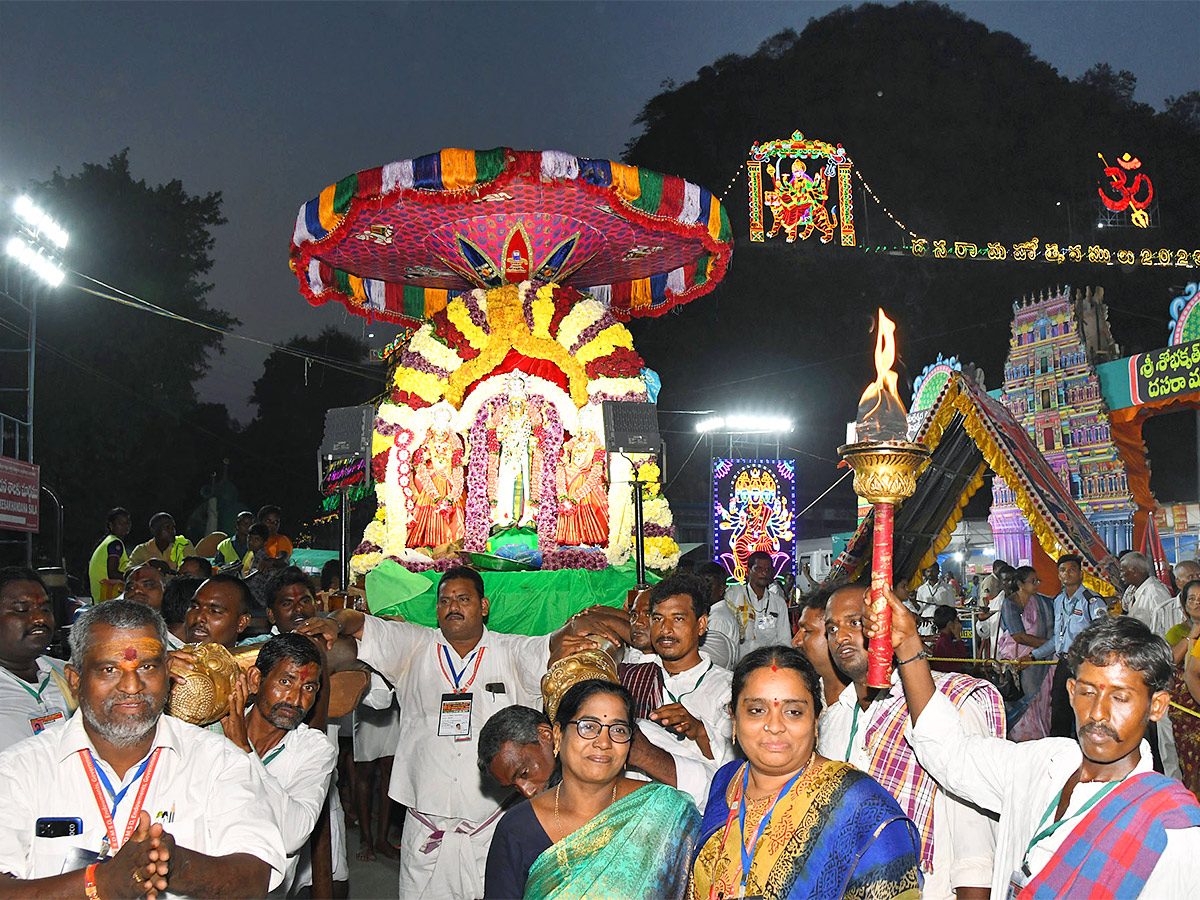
[0, 2, 1200, 420]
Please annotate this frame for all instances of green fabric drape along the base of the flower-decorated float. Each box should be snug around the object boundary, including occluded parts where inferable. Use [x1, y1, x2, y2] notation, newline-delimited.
[367, 559, 659, 635]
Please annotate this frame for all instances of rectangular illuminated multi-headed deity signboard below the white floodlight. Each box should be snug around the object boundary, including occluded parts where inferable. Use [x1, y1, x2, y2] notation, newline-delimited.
[713, 460, 796, 581]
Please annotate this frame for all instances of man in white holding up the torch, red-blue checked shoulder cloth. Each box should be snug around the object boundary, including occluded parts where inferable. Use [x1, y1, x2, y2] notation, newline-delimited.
[868, 598, 1200, 900]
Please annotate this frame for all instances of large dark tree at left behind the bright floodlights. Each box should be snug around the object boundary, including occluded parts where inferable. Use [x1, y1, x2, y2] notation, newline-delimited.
[4, 150, 238, 570]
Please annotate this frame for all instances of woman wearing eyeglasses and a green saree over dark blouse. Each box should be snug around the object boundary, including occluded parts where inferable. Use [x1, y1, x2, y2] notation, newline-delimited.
[484, 679, 700, 900]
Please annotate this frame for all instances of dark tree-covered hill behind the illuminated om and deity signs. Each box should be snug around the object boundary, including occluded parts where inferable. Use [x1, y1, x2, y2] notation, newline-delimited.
[625, 2, 1200, 530]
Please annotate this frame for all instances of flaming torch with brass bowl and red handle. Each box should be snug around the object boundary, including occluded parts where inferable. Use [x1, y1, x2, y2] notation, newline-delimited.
[838, 310, 929, 688]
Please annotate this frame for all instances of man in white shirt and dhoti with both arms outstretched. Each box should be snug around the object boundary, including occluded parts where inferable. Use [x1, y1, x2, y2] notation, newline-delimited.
[298, 566, 609, 900]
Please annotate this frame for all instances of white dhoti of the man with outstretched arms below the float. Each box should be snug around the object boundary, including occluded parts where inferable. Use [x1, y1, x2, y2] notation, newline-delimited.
[400, 809, 503, 900]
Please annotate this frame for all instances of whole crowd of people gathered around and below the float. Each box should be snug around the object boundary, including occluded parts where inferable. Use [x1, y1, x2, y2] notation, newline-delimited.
[0, 508, 1200, 900]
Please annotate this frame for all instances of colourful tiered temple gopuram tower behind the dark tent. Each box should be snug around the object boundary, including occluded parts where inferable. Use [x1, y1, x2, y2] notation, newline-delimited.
[988, 287, 1135, 565]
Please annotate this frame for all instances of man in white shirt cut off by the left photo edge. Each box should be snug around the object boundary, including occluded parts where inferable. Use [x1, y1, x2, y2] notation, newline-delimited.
[0, 566, 74, 750]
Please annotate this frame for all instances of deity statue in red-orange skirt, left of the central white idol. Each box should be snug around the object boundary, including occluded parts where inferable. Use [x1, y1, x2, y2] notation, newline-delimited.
[407, 402, 464, 547]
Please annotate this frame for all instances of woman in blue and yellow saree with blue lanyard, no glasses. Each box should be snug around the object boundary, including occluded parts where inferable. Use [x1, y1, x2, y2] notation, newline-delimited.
[691, 647, 920, 900]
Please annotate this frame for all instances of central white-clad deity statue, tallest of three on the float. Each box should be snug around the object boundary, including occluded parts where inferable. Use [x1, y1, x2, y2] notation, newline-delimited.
[487, 374, 541, 528]
